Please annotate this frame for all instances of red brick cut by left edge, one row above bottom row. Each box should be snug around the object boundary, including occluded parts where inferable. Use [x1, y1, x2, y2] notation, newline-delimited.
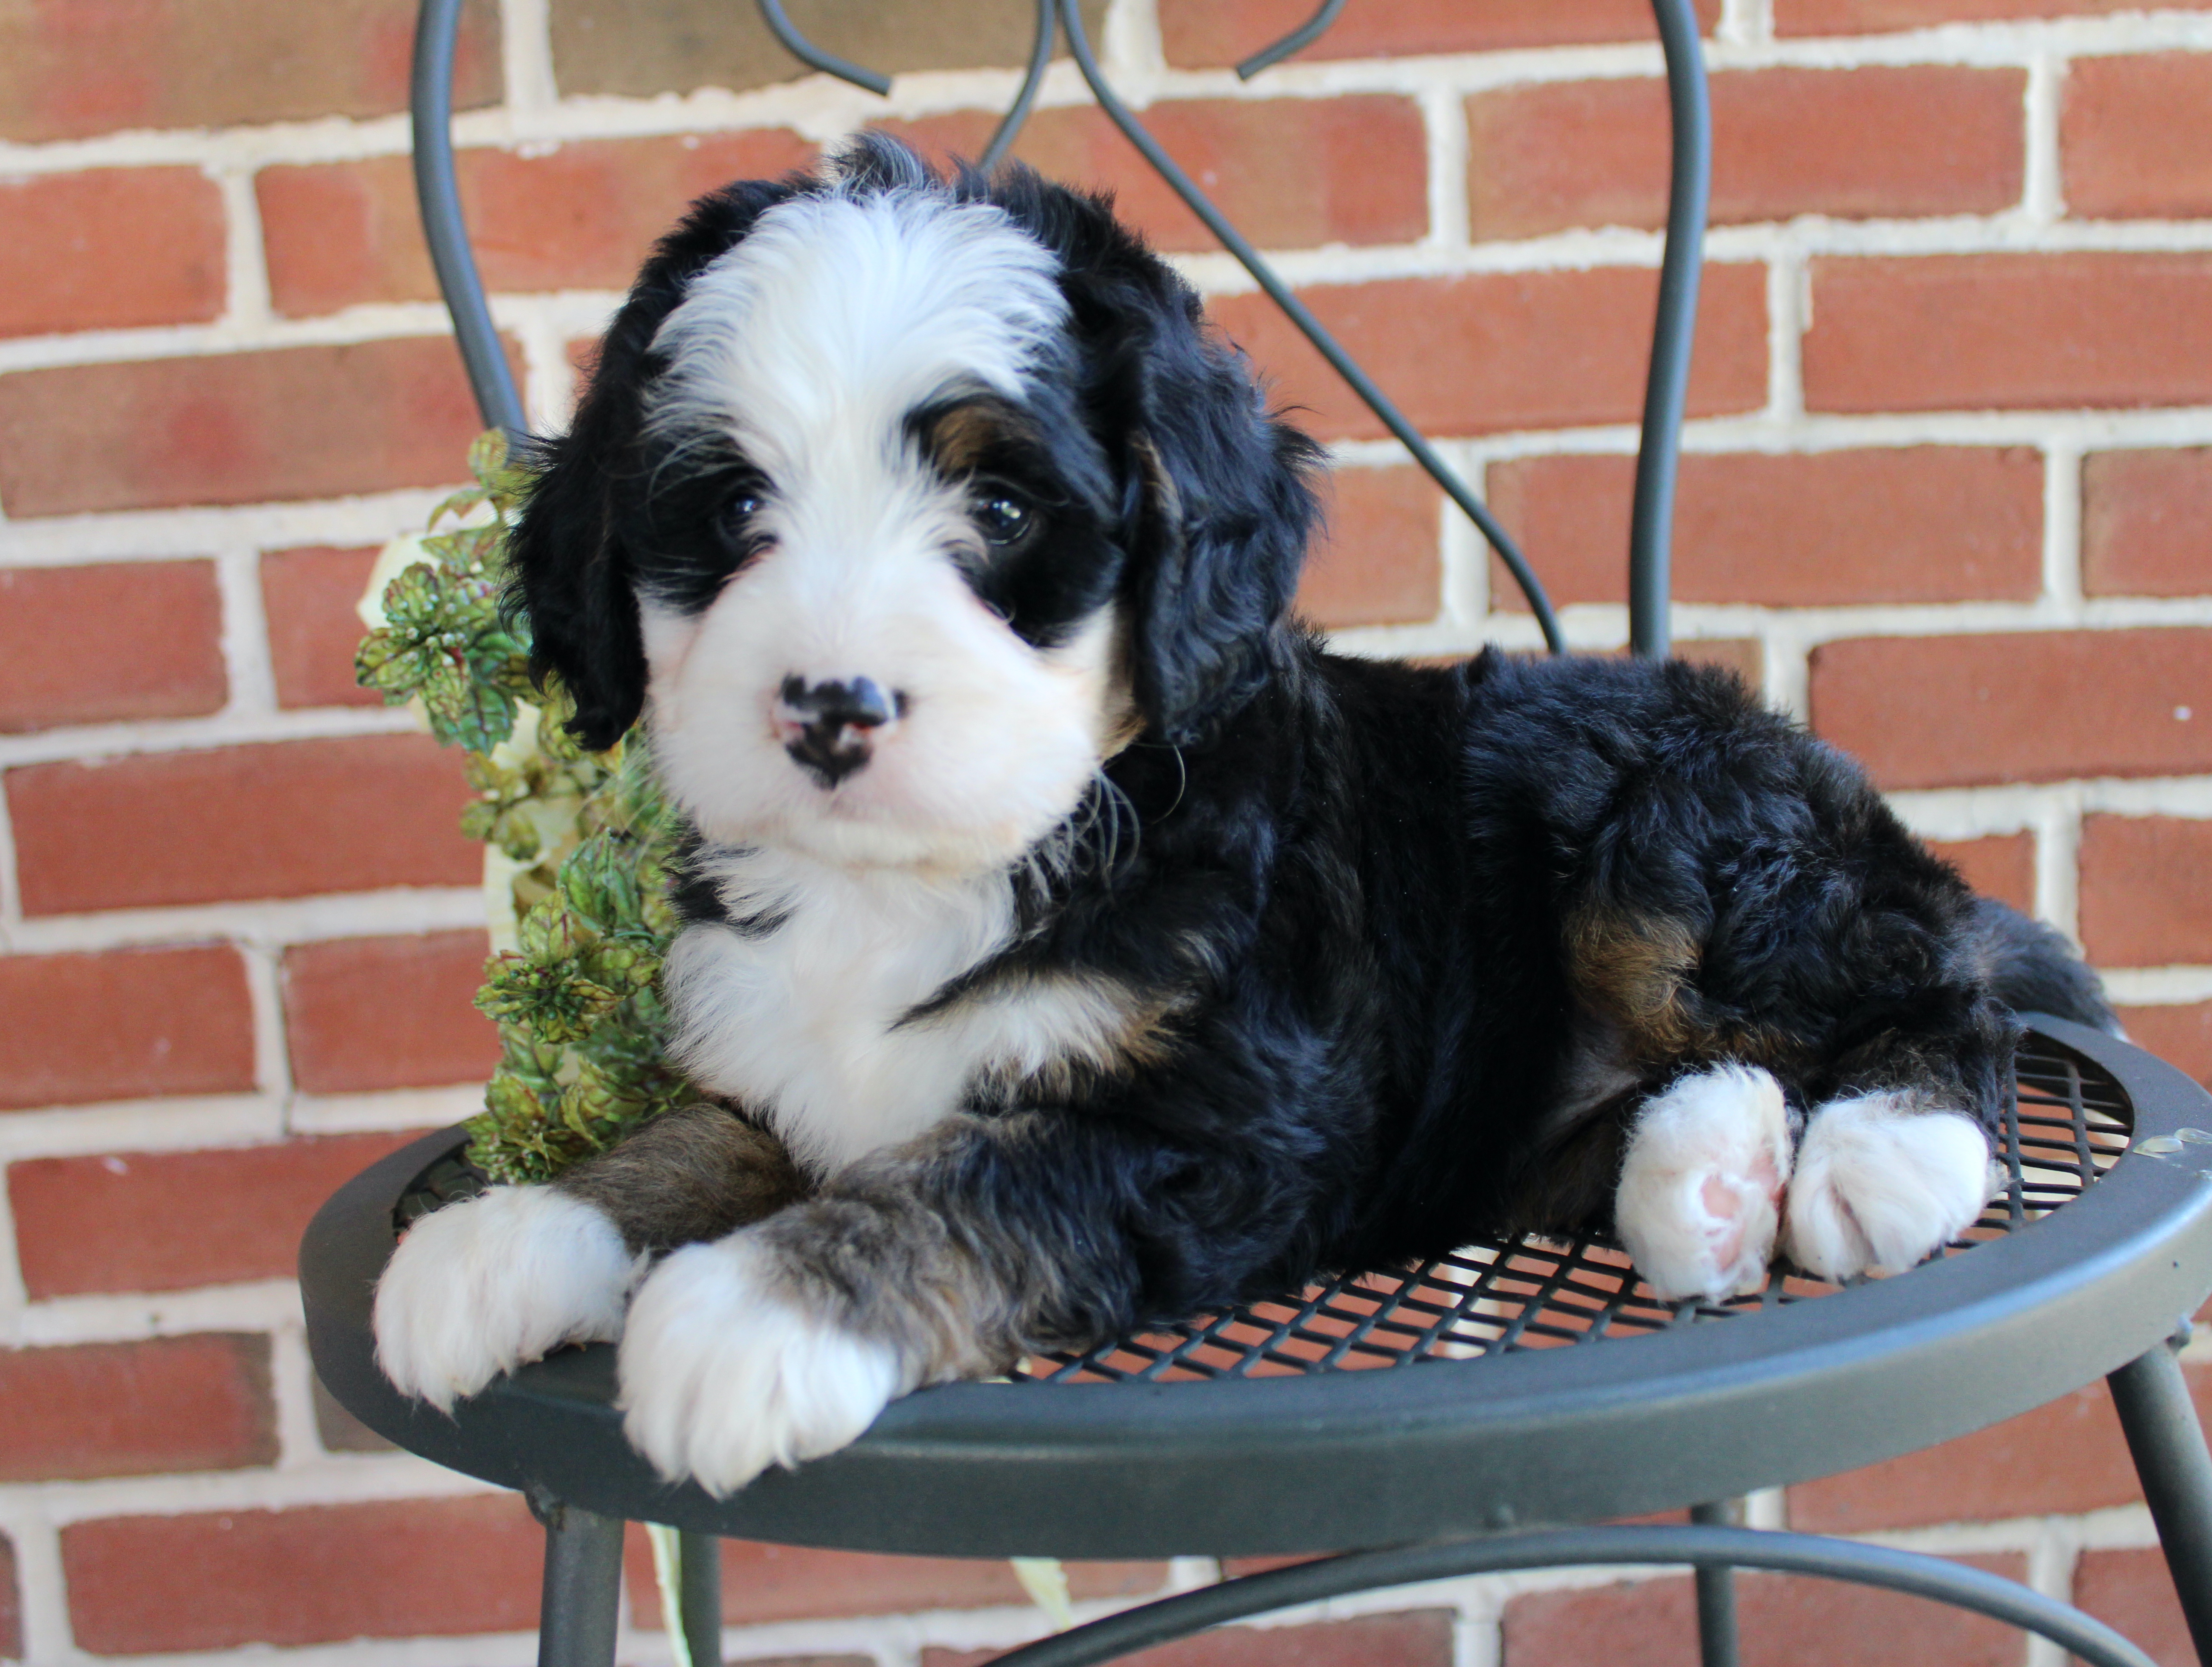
[0, 1333, 276, 1481]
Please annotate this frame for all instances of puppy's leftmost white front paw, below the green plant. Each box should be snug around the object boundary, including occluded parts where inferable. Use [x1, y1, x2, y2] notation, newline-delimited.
[376, 1187, 646, 1411]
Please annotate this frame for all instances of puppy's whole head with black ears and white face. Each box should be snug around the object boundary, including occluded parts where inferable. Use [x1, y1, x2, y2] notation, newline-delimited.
[513, 139, 1314, 871]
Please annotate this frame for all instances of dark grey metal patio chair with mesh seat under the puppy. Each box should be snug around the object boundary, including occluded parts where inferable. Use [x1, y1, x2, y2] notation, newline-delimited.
[301, 0, 2212, 1667]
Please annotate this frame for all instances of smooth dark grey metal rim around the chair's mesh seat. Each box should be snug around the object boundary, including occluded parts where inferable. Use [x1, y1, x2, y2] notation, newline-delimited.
[301, 1017, 2212, 1558]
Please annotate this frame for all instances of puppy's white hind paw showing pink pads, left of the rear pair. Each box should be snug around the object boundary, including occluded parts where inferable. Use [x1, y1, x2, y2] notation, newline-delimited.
[1612, 1066, 1789, 1302]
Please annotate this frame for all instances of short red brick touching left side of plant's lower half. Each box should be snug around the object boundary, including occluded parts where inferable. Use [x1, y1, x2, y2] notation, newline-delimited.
[283, 931, 500, 1094]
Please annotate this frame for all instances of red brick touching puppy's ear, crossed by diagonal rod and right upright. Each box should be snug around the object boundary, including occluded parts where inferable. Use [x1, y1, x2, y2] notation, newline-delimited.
[1212, 265, 1768, 440]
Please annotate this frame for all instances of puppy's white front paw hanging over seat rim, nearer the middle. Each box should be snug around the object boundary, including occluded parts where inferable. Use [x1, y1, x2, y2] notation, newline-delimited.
[619, 1234, 903, 1497]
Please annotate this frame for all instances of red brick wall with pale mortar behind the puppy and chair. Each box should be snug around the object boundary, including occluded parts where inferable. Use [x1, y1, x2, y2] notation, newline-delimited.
[0, 0, 2212, 1667]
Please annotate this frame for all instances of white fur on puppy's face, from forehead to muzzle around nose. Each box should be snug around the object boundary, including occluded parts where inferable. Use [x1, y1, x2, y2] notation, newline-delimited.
[644, 192, 1115, 873]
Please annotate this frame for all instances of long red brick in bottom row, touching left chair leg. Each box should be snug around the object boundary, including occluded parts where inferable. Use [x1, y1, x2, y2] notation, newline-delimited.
[62, 1494, 544, 1656]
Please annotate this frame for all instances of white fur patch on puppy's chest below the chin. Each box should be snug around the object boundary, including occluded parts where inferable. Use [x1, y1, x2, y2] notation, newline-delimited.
[664, 851, 1130, 1172]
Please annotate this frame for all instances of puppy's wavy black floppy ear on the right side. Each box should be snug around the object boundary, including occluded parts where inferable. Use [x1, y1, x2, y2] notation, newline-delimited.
[1128, 301, 1321, 745]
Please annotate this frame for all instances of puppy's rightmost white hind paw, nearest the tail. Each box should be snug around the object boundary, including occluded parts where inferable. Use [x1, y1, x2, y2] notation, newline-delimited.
[1783, 1092, 1993, 1280]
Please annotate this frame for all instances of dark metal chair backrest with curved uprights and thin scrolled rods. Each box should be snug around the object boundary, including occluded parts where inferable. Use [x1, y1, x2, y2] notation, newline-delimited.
[414, 0, 1712, 657]
